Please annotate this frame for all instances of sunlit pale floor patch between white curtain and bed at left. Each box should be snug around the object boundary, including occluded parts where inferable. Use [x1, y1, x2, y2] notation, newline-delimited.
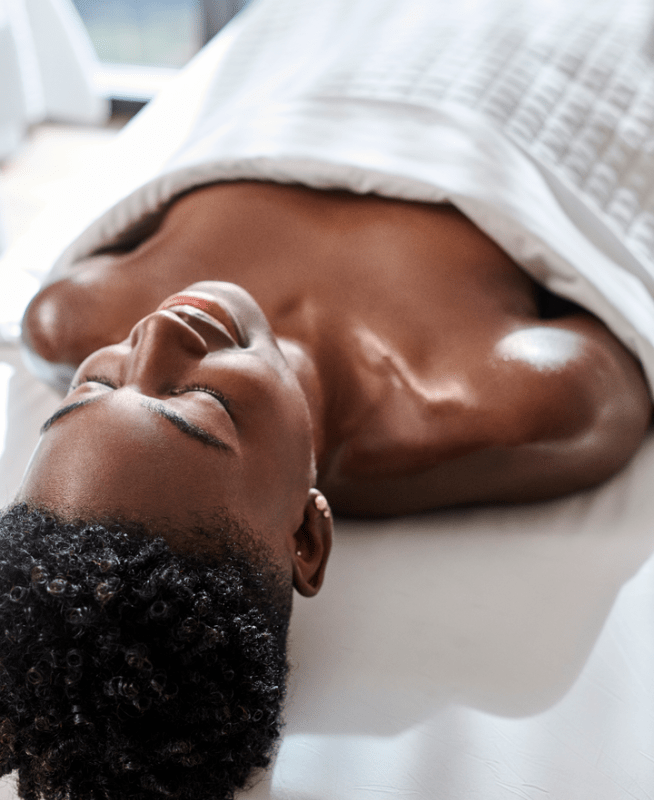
[0, 118, 126, 243]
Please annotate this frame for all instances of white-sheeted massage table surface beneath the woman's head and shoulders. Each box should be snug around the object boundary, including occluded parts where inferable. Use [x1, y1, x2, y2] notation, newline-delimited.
[0, 0, 654, 800]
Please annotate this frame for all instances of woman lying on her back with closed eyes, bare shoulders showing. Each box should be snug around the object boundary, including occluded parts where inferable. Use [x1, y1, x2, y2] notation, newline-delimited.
[0, 0, 651, 800]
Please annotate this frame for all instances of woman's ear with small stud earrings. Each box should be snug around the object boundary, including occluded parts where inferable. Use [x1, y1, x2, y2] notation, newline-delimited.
[293, 489, 334, 597]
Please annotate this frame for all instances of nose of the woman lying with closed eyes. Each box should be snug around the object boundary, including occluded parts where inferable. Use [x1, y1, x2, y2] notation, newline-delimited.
[124, 311, 209, 388]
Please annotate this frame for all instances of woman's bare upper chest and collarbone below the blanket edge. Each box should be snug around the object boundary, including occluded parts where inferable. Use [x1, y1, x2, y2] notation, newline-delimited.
[88, 183, 535, 471]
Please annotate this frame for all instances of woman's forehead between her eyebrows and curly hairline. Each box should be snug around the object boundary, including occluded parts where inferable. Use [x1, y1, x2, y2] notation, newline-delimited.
[19, 396, 242, 521]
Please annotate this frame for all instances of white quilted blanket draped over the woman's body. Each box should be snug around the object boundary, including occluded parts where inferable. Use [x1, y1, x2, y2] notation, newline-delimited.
[1, 0, 654, 384]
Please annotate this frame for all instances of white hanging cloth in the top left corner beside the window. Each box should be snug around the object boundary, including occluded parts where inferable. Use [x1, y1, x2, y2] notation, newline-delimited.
[0, 0, 107, 160]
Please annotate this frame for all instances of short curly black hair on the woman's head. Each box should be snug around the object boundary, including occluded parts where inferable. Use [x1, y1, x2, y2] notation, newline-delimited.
[0, 504, 292, 800]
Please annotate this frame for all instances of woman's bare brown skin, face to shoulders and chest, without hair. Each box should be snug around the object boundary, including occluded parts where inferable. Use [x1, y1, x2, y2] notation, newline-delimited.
[19, 181, 651, 593]
